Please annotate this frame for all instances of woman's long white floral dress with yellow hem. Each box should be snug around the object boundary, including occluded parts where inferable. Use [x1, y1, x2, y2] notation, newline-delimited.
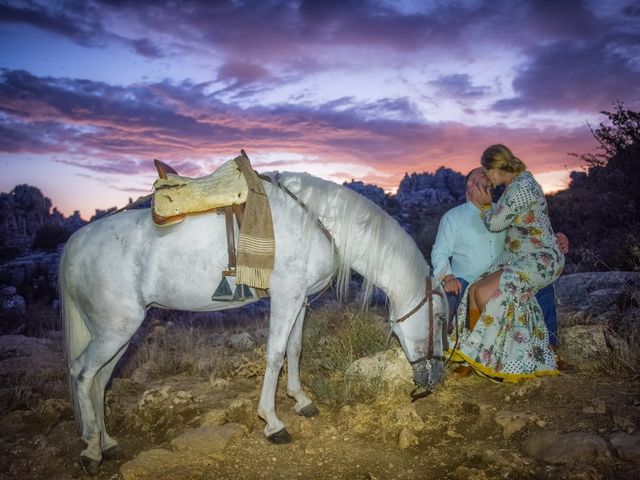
[453, 172, 564, 381]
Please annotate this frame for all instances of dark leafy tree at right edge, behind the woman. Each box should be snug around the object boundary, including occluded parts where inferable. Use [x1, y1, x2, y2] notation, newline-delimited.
[548, 102, 640, 271]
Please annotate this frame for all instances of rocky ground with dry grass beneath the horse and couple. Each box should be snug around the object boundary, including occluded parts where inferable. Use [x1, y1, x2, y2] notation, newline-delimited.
[0, 272, 640, 480]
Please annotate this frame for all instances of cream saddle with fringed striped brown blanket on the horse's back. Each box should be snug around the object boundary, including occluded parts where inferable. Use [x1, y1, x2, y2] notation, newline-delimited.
[156, 150, 275, 289]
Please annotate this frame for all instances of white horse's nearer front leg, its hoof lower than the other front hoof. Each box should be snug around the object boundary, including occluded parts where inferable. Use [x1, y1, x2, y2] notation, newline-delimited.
[258, 298, 303, 443]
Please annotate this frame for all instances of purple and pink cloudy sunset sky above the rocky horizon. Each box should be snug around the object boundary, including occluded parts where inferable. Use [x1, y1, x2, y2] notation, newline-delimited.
[0, 0, 640, 218]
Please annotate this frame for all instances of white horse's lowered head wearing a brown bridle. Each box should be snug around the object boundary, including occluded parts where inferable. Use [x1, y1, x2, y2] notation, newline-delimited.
[394, 279, 449, 398]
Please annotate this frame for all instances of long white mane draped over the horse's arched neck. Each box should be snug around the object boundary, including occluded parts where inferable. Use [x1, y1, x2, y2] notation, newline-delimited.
[268, 172, 429, 304]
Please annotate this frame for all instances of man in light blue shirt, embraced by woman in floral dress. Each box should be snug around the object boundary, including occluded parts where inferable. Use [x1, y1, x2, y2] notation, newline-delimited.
[431, 168, 569, 350]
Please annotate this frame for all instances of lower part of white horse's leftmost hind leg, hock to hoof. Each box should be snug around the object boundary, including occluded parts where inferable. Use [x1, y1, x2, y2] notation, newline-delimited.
[69, 338, 129, 474]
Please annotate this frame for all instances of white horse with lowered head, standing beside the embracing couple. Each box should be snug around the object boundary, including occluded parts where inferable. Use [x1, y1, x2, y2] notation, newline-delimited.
[59, 173, 447, 473]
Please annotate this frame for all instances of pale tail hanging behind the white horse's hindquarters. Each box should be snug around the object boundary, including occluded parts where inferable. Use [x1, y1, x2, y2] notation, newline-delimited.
[58, 244, 91, 430]
